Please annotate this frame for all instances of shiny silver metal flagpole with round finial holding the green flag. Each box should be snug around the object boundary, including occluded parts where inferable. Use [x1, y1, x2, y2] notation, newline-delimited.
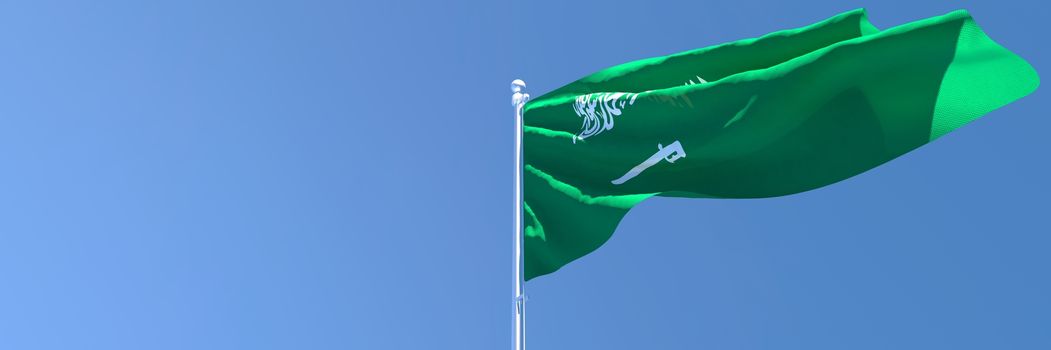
[511, 79, 529, 350]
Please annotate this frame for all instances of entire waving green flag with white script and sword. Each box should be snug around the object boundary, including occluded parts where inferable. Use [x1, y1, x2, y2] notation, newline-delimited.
[523, 9, 1039, 280]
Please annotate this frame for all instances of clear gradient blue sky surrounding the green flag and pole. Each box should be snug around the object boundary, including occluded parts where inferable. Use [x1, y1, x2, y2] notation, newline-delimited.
[0, 0, 1051, 350]
